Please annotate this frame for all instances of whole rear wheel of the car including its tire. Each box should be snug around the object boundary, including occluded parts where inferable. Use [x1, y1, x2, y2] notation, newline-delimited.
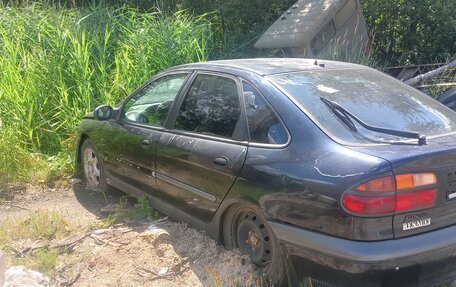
[223, 205, 285, 286]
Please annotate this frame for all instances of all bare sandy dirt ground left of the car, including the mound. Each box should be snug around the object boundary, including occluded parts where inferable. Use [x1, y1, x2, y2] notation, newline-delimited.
[0, 183, 264, 286]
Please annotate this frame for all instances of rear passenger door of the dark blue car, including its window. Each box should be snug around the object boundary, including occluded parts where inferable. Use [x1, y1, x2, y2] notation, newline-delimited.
[156, 72, 248, 222]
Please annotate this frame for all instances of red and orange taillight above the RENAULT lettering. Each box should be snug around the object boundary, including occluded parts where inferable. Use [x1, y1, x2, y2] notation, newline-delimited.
[342, 172, 437, 216]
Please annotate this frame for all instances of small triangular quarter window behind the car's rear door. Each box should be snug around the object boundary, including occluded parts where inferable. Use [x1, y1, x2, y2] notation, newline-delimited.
[242, 82, 288, 144]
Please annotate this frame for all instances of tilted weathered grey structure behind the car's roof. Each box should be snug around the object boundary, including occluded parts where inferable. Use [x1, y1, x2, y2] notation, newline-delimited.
[255, 0, 369, 58]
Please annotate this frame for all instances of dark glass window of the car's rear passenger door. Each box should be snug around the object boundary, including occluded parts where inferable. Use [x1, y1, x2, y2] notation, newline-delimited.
[175, 74, 241, 138]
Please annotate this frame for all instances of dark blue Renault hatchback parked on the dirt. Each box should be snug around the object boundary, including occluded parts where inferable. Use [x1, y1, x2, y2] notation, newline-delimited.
[77, 59, 456, 286]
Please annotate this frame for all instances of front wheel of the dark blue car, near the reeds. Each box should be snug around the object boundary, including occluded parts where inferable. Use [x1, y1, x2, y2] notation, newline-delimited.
[81, 139, 109, 192]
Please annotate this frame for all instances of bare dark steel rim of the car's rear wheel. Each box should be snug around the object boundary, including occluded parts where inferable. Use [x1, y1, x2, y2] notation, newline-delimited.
[235, 211, 273, 267]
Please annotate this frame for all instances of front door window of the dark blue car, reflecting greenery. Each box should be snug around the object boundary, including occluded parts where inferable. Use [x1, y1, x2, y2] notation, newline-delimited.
[123, 73, 188, 126]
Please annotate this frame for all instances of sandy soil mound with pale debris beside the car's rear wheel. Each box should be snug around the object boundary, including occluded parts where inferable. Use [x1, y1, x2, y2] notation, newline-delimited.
[59, 220, 259, 287]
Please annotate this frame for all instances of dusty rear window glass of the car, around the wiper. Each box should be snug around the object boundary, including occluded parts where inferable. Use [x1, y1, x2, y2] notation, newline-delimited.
[268, 69, 456, 144]
